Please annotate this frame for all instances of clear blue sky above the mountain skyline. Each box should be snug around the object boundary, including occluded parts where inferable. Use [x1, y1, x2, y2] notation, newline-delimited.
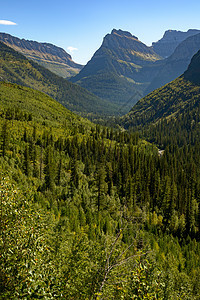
[0, 0, 200, 64]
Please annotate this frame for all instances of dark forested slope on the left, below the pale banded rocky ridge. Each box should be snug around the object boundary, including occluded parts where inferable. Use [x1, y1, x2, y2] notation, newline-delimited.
[0, 43, 116, 115]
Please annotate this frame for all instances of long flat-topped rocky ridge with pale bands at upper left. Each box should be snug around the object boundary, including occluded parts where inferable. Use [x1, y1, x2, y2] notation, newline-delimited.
[0, 33, 83, 78]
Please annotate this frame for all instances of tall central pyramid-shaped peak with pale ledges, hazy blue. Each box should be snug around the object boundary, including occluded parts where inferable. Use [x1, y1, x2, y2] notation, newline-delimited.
[70, 29, 161, 110]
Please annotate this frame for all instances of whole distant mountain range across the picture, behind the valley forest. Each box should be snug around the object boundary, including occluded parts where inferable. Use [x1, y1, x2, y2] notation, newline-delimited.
[0, 29, 200, 117]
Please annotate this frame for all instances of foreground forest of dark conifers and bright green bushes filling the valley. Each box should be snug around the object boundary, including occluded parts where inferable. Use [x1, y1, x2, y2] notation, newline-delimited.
[0, 83, 200, 300]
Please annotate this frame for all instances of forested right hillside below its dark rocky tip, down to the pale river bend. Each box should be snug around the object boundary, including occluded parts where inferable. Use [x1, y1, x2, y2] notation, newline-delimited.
[121, 76, 200, 148]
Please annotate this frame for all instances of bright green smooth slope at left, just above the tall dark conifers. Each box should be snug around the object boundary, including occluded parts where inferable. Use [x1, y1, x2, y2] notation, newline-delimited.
[0, 82, 91, 129]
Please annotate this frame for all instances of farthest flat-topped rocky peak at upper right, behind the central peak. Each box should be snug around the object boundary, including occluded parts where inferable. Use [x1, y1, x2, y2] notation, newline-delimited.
[152, 29, 200, 58]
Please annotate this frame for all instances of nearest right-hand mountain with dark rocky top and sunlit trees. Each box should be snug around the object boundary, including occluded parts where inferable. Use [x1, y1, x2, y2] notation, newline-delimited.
[122, 51, 200, 132]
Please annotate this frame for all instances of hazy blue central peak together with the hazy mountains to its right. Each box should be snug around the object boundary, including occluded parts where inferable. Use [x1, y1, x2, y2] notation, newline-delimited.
[70, 29, 200, 111]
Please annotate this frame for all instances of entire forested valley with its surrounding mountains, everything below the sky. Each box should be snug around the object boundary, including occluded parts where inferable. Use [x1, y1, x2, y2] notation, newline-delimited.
[0, 29, 200, 300]
